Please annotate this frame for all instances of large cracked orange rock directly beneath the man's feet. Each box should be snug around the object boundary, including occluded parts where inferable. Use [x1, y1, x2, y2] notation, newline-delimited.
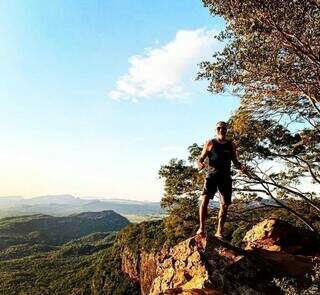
[149, 235, 273, 295]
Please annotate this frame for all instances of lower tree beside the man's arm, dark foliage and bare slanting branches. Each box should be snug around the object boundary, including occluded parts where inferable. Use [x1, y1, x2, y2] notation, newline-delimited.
[230, 112, 320, 230]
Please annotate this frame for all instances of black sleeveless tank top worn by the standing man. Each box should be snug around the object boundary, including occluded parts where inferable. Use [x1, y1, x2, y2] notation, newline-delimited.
[208, 139, 232, 176]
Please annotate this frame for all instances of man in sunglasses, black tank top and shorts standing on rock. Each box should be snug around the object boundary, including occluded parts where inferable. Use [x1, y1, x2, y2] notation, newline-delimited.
[197, 121, 248, 238]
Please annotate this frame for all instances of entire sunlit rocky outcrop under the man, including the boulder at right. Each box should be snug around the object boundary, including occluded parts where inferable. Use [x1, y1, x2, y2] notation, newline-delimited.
[122, 219, 319, 295]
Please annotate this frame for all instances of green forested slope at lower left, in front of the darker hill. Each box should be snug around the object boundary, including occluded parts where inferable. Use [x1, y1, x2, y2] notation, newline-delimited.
[0, 233, 114, 295]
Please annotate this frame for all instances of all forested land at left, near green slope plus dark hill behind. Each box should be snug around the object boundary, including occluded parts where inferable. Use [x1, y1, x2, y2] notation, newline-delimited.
[0, 211, 129, 294]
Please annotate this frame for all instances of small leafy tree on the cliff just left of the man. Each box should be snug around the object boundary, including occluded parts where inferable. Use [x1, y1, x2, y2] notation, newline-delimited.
[159, 150, 203, 244]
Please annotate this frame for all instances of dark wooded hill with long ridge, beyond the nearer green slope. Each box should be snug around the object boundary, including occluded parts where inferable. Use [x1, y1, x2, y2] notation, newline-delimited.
[0, 210, 130, 250]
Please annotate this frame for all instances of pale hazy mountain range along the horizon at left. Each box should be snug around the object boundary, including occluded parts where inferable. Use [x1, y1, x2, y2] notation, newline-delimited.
[0, 195, 163, 218]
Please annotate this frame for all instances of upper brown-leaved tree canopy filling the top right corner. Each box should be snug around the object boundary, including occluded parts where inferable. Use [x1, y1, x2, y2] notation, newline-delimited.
[199, 0, 320, 121]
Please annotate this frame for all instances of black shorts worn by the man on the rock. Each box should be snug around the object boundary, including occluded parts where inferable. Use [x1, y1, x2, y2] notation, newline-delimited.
[202, 174, 232, 205]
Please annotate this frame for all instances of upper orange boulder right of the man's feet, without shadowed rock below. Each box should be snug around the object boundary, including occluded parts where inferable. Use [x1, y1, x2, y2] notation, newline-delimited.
[243, 219, 320, 256]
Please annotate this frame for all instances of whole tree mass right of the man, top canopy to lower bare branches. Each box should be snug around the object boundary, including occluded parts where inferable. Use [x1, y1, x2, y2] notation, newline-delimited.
[198, 0, 320, 229]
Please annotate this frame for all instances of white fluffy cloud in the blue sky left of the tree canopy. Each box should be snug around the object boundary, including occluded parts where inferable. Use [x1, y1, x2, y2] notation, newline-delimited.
[109, 29, 218, 102]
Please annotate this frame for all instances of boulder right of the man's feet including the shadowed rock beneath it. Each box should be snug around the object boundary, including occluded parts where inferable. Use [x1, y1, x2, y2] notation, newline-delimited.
[243, 219, 320, 278]
